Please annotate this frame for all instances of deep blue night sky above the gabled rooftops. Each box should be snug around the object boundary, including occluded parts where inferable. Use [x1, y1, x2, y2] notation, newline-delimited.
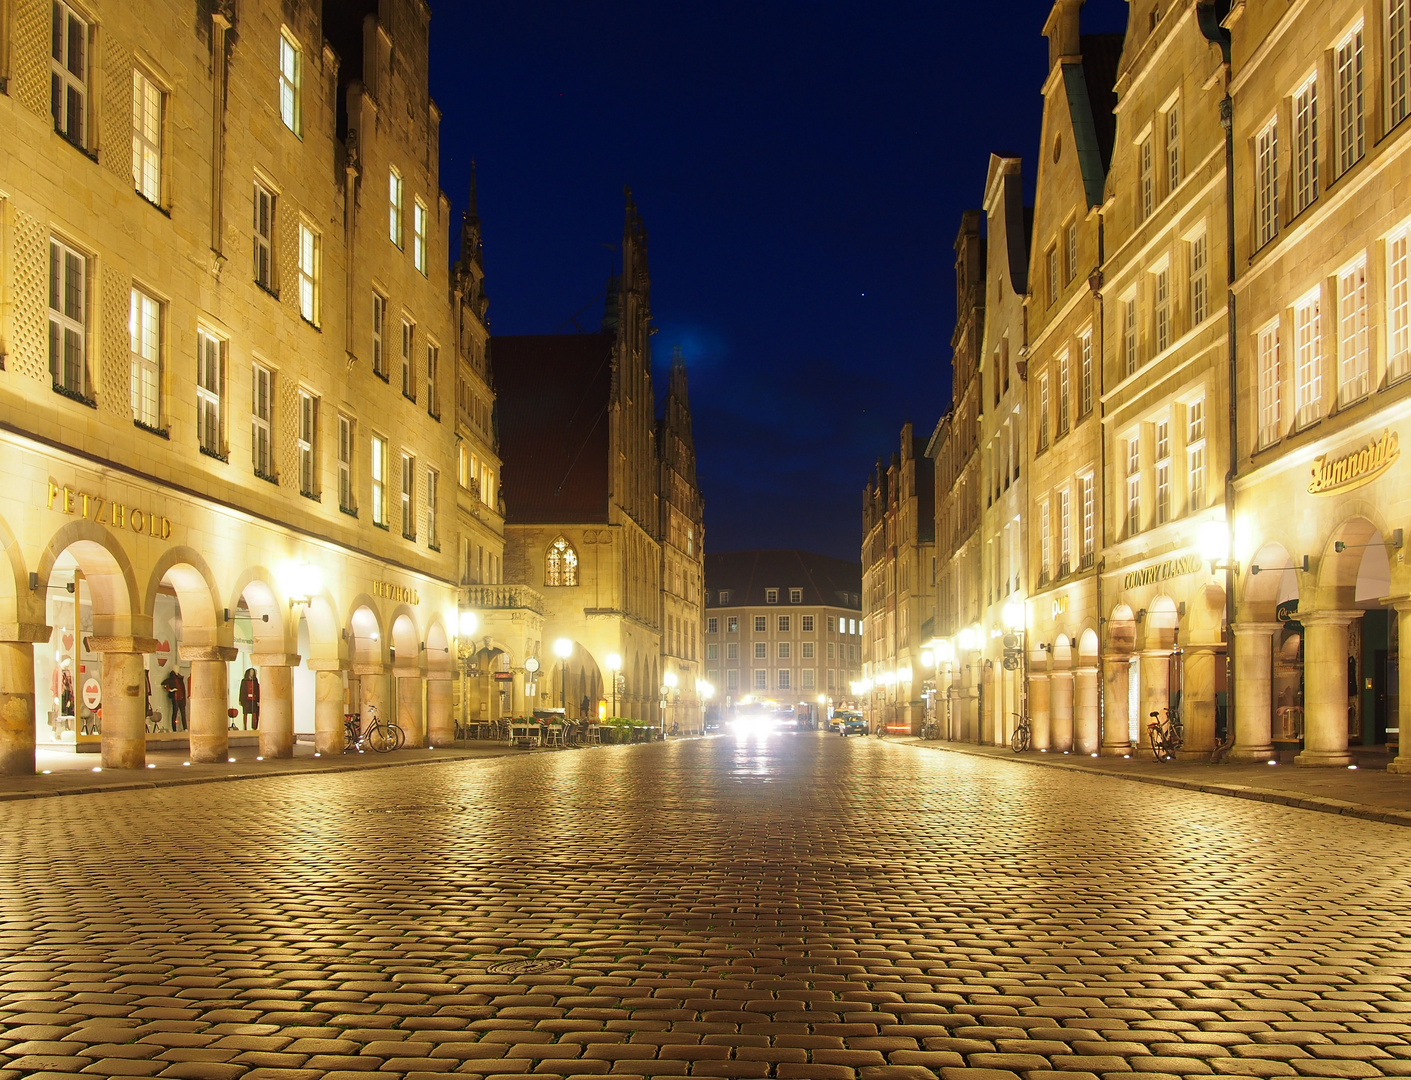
[432, 0, 1126, 559]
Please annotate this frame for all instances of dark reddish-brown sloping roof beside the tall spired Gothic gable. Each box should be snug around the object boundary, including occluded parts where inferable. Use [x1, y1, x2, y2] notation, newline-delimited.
[490, 333, 614, 524]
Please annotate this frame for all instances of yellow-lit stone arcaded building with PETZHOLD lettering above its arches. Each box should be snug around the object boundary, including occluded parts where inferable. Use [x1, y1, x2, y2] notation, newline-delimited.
[0, 0, 474, 772]
